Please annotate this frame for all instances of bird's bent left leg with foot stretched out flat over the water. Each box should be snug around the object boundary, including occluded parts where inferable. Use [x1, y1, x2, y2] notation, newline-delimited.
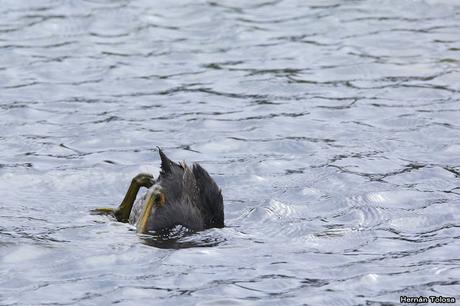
[91, 173, 155, 222]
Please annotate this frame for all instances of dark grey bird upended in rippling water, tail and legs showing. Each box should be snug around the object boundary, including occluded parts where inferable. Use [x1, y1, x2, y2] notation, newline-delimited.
[92, 148, 224, 233]
